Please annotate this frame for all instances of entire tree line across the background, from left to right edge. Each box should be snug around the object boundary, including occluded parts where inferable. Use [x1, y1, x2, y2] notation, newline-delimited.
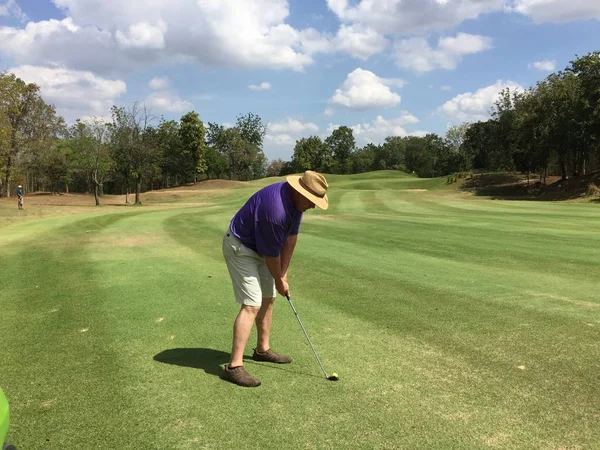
[0, 52, 600, 204]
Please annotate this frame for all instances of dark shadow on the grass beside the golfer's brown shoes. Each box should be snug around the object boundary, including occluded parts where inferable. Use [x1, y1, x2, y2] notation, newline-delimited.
[154, 348, 229, 376]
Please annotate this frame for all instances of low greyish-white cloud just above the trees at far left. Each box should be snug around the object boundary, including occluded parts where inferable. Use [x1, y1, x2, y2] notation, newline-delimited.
[10, 65, 127, 122]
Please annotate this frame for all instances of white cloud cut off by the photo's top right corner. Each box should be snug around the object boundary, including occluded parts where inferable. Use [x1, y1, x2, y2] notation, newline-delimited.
[508, 0, 600, 23]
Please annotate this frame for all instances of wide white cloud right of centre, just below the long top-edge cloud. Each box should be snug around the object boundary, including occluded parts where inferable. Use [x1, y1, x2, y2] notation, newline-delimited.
[394, 33, 492, 72]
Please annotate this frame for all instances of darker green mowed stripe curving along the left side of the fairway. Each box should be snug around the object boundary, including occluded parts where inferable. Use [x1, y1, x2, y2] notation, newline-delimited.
[1, 214, 170, 449]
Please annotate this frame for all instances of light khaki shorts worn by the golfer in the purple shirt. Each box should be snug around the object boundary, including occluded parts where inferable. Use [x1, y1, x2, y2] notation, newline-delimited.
[223, 231, 277, 306]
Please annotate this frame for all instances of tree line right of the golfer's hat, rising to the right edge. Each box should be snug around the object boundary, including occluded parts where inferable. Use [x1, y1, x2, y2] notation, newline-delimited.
[269, 52, 600, 185]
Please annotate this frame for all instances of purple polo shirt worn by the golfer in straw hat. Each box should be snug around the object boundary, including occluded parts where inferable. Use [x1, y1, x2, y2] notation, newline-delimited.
[229, 181, 302, 257]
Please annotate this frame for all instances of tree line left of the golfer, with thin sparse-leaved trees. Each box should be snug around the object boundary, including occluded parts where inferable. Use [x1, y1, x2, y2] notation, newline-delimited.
[0, 73, 267, 205]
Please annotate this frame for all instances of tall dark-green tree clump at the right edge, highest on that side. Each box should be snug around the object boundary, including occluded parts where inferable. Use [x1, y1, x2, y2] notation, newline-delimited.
[463, 51, 600, 185]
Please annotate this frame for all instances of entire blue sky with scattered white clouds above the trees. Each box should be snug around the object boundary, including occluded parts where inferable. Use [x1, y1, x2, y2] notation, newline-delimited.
[0, 0, 600, 159]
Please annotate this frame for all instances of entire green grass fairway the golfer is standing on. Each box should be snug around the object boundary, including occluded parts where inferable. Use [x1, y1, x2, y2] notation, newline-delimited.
[0, 171, 600, 450]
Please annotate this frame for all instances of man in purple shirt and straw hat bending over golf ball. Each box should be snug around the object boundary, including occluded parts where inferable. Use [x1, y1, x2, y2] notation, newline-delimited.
[222, 170, 328, 387]
